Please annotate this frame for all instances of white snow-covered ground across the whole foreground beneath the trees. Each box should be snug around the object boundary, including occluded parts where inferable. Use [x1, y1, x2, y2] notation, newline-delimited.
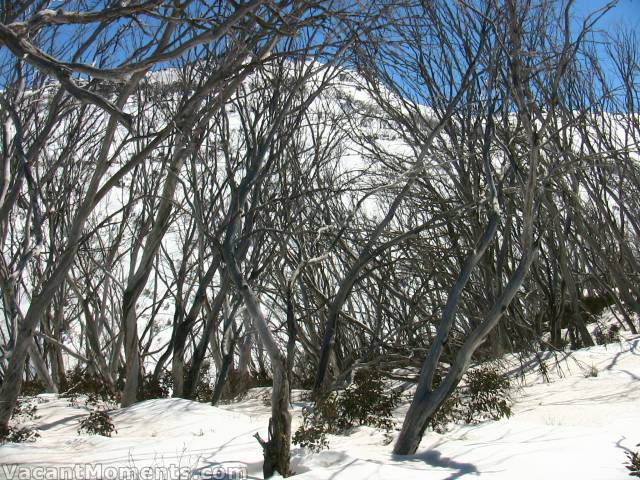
[0, 336, 640, 480]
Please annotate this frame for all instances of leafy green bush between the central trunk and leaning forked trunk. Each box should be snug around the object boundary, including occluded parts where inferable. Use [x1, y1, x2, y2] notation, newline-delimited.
[293, 369, 400, 452]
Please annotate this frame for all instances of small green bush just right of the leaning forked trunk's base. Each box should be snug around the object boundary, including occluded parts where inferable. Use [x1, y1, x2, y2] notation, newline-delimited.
[428, 367, 511, 433]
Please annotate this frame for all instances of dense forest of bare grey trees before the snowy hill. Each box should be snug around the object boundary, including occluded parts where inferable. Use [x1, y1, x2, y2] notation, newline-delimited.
[0, 0, 640, 476]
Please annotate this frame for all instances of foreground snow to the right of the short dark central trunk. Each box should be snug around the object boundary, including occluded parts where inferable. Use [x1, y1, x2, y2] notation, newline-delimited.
[290, 339, 640, 480]
